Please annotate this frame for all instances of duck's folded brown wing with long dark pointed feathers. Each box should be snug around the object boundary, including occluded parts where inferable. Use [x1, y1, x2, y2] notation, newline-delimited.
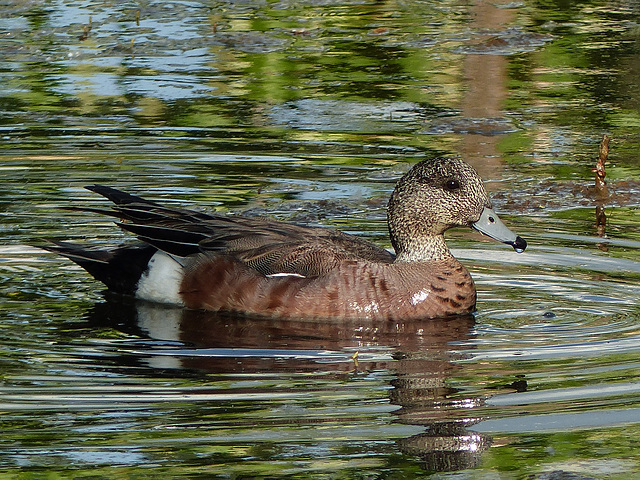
[85, 185, 394, 277]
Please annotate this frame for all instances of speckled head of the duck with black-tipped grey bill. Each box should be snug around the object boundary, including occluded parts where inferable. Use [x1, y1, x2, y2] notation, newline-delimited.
[388, 157, 527, 260]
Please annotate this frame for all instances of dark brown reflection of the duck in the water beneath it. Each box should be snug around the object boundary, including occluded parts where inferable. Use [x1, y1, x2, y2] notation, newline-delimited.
[89, 298, 490, 471]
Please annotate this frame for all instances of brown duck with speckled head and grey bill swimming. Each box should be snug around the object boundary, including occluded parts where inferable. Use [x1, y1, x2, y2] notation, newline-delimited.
[44, 157, 527, 321]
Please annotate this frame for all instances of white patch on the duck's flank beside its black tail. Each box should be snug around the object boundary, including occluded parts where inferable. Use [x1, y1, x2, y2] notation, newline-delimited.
[136, 251, 184, 306]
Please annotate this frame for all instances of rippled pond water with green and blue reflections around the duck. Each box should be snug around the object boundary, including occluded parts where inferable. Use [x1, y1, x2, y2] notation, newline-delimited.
[0, 0, 640, 480]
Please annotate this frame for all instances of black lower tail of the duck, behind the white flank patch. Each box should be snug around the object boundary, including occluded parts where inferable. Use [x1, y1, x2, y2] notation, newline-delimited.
[41, 242, 157, 295]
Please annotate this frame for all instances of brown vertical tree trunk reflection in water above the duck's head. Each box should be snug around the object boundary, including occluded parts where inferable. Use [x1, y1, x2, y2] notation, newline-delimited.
[460, 0, 514, 178]
